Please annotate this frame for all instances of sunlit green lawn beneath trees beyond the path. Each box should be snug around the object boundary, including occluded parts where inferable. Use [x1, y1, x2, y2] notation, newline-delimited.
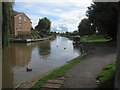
[81, 35, 111, 42]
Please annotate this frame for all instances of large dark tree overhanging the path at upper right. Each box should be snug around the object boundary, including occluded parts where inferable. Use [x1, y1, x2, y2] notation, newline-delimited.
[86, 2, 118, 40]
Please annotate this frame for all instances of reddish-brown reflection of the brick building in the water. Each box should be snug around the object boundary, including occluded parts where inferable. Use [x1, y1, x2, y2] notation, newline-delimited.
[11, 44, 32, 67]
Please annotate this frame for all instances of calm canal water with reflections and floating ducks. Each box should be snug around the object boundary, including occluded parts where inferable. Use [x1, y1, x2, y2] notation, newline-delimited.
[2, 36, 81, 88]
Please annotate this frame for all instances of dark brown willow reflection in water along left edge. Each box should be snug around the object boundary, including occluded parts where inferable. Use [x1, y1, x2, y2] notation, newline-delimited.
[2, 48, 14, 88]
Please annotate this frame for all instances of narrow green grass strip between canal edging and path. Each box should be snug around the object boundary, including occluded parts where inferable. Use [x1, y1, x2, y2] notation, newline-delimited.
[31, 56, 85, 88]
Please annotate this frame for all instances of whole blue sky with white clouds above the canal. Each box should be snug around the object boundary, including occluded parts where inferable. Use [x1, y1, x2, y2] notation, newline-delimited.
[14, 0, 92, 32]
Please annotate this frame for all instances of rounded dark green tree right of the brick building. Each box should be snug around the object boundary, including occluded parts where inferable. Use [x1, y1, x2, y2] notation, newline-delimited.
[35, 17, 51, 35]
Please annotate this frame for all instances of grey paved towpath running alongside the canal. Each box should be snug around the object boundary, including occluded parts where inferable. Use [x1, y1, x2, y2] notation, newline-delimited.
[62, 42, 116, 88]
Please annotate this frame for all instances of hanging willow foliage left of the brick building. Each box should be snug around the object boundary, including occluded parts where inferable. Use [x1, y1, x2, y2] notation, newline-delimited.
[2, 2, 13, 48]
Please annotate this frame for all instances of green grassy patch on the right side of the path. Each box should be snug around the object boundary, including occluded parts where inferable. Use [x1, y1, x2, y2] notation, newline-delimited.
[97, 62, 116, 88]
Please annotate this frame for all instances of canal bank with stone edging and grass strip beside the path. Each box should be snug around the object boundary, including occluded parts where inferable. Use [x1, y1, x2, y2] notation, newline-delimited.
[16, 54, 86, 88]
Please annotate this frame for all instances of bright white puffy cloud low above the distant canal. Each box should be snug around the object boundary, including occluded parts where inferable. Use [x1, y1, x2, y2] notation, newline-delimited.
[52, 10, 86, 32]
